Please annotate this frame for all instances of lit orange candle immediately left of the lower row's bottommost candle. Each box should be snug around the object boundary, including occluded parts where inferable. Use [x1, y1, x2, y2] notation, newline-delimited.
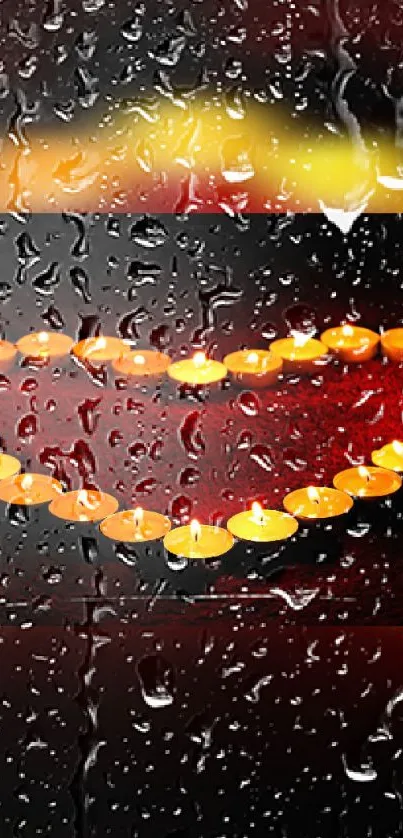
[99, 507, 171, 543]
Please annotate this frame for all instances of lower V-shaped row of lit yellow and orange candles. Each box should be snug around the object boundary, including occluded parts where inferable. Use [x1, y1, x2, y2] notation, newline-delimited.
[0, 440, 403, 559]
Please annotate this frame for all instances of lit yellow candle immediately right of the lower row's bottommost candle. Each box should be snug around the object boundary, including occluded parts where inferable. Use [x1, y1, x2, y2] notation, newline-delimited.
[227, 503, 298, 542]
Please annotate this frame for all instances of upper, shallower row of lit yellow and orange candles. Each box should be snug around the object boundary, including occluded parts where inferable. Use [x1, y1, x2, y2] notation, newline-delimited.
[0, 324, 403, 387]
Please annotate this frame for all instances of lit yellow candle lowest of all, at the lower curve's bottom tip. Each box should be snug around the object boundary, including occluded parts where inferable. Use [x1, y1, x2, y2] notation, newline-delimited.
[164, 521, 234, 559]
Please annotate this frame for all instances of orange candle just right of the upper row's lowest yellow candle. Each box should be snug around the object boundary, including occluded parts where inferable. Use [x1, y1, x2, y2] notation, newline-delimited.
[224, 349, 283, 389]
